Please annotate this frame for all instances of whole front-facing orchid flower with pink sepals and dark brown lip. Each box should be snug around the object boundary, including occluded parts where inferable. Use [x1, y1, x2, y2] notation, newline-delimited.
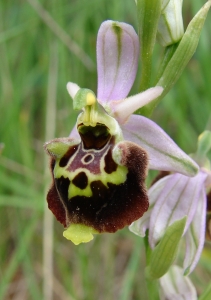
[45, 21, 198, 244]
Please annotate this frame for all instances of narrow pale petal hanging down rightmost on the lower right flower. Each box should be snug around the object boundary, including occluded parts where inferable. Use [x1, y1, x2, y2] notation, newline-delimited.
[183, 189, 207, 275]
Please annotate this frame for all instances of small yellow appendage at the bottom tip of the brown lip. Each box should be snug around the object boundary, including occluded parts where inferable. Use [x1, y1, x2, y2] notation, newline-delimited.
[63, 224, 99, 245]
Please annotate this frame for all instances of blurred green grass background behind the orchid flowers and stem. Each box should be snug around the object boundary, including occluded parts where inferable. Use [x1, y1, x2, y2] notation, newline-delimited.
[0, 0, 211, 300]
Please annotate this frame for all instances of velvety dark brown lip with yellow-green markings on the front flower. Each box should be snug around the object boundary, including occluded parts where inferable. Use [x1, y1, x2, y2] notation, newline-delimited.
[46, 131, 149, 232]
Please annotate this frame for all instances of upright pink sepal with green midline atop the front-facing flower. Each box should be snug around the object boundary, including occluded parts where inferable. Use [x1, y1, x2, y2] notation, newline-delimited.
[97, 21, 139, 104]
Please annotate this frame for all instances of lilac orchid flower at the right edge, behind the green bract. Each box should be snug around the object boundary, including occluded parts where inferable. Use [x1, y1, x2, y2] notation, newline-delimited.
[129, 132, 211, 275]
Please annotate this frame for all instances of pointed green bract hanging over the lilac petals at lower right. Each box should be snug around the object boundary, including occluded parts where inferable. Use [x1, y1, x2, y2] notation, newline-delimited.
[145, 217, 187, 280]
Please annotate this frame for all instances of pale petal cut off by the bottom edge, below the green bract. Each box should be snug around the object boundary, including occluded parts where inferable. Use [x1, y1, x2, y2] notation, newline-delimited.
[160, 265, 197, 300]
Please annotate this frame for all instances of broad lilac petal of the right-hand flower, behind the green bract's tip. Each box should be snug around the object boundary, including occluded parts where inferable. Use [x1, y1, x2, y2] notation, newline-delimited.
[149, 172, 206, 247]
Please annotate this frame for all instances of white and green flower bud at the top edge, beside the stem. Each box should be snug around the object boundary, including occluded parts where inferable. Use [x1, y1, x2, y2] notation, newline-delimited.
[157, 0, 184, 47]
